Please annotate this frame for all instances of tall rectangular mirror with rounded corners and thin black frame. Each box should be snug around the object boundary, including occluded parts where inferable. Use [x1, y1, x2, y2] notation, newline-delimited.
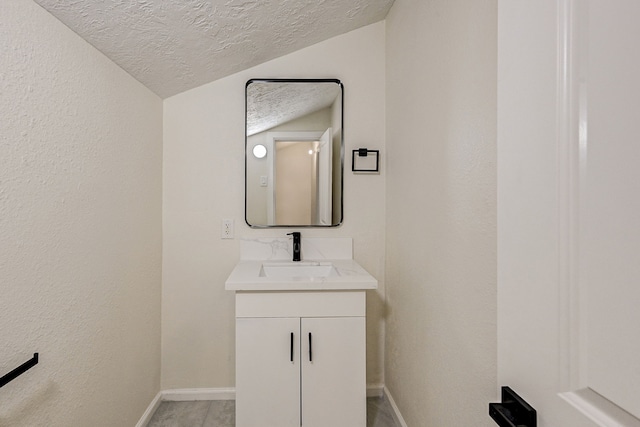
[245, 79, 344, 228]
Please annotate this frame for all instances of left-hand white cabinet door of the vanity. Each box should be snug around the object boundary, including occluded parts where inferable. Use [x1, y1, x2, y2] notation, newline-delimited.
[236, 318, 300, 427]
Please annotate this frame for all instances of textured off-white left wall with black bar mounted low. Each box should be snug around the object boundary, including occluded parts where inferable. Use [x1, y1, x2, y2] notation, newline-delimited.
[0, 0, 162, 427]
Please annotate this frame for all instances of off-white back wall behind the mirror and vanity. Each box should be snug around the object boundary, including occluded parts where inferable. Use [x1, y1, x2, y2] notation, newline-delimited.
[162, 23, 385, 389]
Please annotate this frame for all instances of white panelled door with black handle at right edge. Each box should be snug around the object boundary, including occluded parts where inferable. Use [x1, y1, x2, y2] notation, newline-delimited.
[498, 0, 640, 427]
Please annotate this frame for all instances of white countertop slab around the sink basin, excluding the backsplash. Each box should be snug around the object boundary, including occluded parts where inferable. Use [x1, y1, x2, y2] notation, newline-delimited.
[225, 259, 378, 291]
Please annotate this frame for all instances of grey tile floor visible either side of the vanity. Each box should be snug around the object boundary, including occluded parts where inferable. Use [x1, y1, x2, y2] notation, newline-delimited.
[147, 397, 399, 427]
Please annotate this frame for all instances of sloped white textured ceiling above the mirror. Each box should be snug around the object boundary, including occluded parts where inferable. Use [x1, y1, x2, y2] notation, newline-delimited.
[34, 0, 394, 98]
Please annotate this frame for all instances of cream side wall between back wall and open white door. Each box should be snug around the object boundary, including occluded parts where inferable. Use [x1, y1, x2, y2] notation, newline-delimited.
[385, 0, 497, 426]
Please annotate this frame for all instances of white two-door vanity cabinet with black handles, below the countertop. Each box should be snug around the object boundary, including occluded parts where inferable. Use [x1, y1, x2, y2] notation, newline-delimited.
[236, 290, 366, 427]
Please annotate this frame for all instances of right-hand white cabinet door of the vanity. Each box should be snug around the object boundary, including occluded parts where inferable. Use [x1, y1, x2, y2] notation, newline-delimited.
[300, 317, 367, 427]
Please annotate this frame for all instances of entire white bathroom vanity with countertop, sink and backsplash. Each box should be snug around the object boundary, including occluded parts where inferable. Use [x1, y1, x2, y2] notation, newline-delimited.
[225, 239, 377, 427]
